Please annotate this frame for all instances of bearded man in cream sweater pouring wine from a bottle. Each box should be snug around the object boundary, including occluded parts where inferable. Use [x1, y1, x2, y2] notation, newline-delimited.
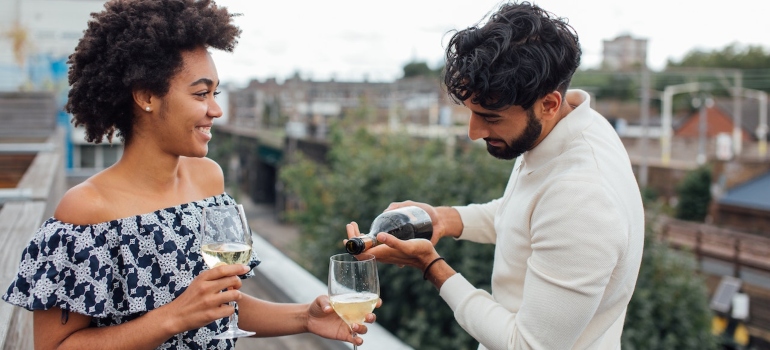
[347, 2, 644, 350]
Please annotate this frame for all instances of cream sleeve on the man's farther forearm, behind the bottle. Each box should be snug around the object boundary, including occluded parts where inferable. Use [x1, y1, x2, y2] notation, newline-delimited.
[453, 198, 501, 244]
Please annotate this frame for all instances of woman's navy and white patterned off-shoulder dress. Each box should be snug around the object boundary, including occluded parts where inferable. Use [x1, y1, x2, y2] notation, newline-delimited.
[3, 193, 259, 349]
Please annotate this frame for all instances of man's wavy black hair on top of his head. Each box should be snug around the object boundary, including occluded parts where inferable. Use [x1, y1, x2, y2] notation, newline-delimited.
[444, 2, 581, 110]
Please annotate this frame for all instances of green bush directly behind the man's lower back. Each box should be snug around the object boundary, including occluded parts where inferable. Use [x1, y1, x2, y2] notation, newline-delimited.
[622, 225, 717, 350]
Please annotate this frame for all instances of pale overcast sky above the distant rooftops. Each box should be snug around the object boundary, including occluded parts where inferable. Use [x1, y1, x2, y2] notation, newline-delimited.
[207, 0, 770, 85]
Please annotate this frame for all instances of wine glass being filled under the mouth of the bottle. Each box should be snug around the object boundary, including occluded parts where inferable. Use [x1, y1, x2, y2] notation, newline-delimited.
[329, 253, 380, 350]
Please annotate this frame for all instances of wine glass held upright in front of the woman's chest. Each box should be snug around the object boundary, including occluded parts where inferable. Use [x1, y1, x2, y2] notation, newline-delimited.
[201, 204, 255, 339]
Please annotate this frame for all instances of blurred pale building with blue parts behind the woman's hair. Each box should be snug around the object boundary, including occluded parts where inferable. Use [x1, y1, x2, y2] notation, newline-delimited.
[0, 0, 114, 177]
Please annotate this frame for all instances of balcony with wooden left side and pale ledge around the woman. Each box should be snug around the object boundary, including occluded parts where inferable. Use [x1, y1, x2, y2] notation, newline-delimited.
[0, 93, 411, 350]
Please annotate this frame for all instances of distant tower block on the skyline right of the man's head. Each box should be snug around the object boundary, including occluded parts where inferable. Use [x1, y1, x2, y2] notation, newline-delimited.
[602, 35, 647, 70]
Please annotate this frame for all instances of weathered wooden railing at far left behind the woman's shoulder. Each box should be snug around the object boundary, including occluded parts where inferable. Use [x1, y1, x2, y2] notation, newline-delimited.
[0, 130, 66, 350]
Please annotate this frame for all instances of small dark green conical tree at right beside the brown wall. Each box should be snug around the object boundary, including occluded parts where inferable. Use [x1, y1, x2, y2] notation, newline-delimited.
[675, 166, 711, 222]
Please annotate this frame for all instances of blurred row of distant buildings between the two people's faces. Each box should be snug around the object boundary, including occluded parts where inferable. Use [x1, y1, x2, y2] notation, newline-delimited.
[229, 75, 468, 139]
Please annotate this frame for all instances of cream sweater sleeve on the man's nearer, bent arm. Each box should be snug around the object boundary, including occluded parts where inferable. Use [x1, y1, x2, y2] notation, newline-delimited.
[440, 180, 628, 350]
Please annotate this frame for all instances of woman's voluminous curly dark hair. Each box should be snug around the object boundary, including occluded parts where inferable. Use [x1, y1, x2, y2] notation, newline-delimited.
[65, 0, 241, 143]
